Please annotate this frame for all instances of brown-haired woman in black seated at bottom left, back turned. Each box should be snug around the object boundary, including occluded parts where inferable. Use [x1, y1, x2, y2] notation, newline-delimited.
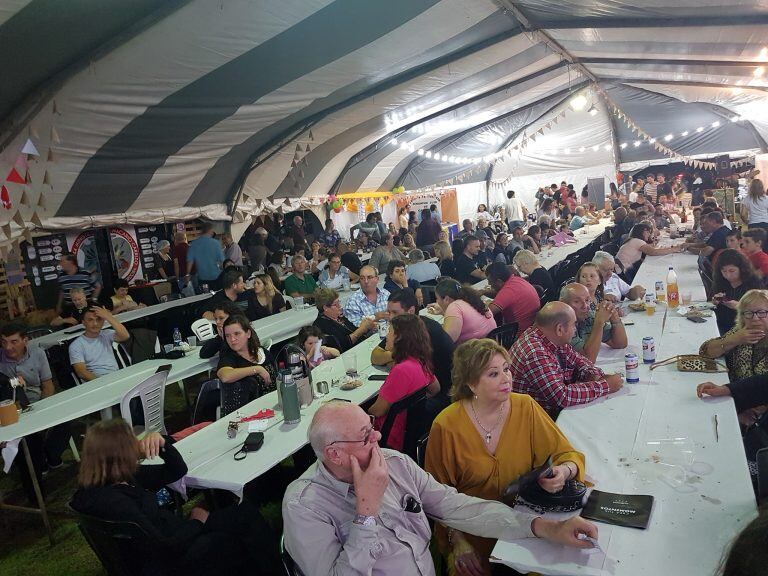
[71, 418, 279, 576]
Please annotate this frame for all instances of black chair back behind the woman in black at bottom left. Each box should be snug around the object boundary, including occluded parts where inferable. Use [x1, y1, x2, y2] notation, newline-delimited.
[70, 506, 155, 576]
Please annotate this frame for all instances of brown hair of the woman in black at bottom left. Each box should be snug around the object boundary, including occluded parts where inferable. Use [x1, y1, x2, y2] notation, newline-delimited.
[77, 418, 141, 488]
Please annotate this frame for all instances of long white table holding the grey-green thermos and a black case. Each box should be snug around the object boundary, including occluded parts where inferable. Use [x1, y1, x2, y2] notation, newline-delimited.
[176, 335, 382, 497]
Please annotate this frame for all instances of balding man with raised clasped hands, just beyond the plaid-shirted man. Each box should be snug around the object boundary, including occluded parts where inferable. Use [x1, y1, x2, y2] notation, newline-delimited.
[560, 282, 627, 362]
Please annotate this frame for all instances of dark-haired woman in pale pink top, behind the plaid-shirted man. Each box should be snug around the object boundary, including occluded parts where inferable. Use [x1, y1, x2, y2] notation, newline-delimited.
[429, 278, 496, 344]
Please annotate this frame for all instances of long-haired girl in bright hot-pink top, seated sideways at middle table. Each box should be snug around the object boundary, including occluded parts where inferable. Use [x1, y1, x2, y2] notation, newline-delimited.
[368, 314, 440, 450]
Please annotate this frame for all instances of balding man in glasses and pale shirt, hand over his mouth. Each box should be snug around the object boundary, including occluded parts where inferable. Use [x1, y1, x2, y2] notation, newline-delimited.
[283, 400, 597, 576]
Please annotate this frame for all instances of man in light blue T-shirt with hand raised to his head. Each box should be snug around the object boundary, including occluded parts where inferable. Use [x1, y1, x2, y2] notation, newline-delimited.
[69, 306, 131, 382]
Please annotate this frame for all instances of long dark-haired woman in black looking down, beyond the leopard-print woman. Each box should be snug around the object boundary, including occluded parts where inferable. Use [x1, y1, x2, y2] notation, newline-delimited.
[712, 250, 764, 334]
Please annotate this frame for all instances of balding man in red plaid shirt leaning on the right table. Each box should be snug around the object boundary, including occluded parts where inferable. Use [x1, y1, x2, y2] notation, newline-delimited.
[510, 302, 622, 415]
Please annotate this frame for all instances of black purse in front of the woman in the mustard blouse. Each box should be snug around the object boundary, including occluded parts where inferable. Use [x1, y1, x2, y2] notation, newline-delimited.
[502, 458, 587, 514]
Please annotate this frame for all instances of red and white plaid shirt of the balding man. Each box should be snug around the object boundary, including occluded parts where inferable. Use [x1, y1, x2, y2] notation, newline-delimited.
[509, 325, 610, 413]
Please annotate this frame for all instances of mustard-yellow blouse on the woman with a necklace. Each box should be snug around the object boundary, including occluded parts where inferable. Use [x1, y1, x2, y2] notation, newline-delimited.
[425, 394, 584, 572]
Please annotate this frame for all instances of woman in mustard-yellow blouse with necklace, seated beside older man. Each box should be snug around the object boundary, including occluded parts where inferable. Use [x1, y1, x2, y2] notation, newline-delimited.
[425, 338, 584, 576]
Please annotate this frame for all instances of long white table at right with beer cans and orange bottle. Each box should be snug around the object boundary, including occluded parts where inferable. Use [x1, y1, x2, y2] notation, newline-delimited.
[493, 248, 757, 576]
